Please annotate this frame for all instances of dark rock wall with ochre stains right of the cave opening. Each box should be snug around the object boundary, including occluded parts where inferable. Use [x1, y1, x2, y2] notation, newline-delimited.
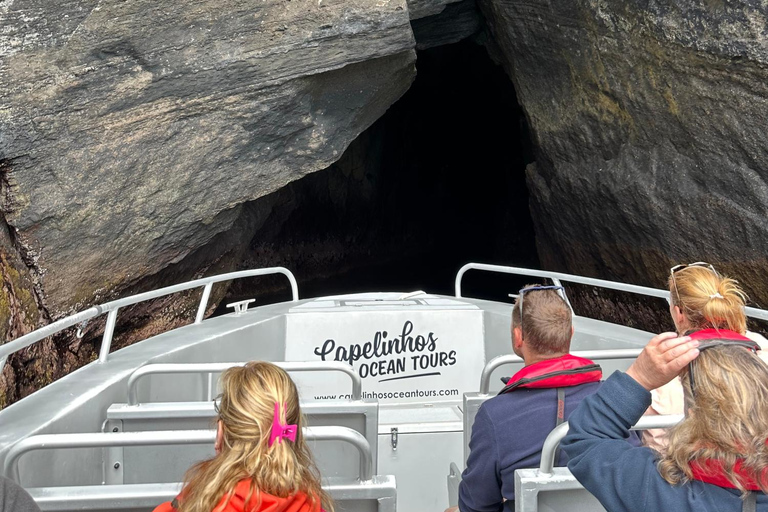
[478, 0, 768, 307]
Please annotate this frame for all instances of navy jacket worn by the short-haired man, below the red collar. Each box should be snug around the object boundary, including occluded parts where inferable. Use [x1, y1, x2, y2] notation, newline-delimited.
[459, 382, 600, 512]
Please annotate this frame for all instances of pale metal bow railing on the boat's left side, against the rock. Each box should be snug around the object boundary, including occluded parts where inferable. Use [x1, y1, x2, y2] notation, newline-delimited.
[0, 267, 299, 373]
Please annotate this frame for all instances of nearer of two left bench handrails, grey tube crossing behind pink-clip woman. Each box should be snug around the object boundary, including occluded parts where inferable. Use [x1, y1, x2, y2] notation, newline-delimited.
[3, 427, 373, 483]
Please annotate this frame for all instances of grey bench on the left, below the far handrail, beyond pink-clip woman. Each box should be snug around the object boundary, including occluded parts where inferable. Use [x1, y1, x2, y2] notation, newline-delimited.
[103, 400, 379, 484]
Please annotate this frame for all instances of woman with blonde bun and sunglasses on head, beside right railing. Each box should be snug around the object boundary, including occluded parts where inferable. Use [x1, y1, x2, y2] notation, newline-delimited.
[643, 262, 766, 452]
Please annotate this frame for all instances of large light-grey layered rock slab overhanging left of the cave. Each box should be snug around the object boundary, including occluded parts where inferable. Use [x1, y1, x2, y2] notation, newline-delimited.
[0, 0, 415, 317]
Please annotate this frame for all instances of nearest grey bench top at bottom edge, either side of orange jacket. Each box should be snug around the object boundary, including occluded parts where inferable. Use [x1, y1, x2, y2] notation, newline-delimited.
[27, 475, 397, 512]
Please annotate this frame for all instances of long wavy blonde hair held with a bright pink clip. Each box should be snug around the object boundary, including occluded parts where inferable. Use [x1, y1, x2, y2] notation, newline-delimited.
[178, 361, 333, 512]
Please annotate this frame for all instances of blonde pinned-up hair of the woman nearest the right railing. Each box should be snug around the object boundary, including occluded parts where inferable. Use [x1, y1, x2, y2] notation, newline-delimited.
[669, 267, 747, 334]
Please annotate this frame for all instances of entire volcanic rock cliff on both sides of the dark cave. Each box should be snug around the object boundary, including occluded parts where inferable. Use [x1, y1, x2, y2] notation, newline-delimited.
[0, 0, 768, 406]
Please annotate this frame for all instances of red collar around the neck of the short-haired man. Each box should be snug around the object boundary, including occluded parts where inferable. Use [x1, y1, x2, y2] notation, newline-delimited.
[499, 354, 603, 394]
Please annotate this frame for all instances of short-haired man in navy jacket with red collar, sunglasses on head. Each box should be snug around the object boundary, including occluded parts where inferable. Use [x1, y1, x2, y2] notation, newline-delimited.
[459, 285, 602, 512]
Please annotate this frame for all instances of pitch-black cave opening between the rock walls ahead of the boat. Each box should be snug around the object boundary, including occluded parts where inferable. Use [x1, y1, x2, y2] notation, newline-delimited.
[225, 39, 539, 312]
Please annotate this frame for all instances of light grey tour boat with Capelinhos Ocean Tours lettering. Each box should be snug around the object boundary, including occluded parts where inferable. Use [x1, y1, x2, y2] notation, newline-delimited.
[0, 263, 768, 512]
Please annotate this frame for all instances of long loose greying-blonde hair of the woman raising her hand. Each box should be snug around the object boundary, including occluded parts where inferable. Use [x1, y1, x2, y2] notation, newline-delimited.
[658, 346, 768, 492]
